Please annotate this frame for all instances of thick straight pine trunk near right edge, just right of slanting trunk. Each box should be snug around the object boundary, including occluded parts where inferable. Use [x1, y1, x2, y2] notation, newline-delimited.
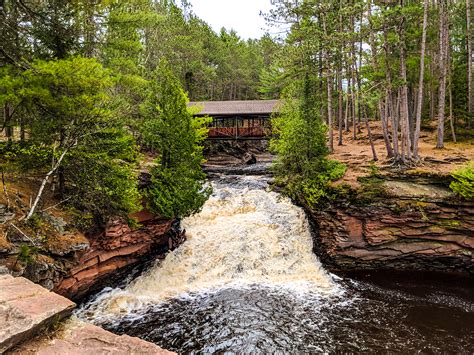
[436, 0, 448, 149]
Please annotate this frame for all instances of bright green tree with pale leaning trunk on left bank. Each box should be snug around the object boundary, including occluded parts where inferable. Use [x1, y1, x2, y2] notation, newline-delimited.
[21, 58, 139, 221]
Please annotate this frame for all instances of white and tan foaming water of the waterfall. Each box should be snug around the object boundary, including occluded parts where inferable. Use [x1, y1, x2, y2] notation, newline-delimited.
[82, 177, 336, 316]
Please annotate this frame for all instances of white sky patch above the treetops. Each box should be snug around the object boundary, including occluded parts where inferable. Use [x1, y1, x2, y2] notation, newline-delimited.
[190, 0, 271, 39]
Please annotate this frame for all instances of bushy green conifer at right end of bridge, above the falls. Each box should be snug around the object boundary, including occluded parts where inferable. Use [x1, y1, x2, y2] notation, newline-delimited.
[270, 76, 346, 208]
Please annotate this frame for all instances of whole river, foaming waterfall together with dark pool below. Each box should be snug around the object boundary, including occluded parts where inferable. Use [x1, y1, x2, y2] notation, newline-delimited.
[76, 175, 474, 353]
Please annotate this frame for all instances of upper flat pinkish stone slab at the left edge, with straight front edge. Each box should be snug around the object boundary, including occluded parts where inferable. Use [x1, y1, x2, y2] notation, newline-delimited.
[0, 275, 76, 353]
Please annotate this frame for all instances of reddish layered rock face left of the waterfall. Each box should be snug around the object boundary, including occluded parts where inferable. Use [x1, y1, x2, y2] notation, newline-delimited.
[54, 215, 183, 299]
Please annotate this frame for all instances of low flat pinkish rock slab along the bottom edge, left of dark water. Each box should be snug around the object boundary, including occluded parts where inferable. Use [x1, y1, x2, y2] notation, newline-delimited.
[13, 324, 175, 355]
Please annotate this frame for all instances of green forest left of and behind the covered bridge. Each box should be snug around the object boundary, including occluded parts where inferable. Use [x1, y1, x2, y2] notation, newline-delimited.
[0, 0, 278, 225]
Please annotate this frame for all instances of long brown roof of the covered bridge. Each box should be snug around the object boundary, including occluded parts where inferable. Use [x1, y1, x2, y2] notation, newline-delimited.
[188, 100, 279, 116]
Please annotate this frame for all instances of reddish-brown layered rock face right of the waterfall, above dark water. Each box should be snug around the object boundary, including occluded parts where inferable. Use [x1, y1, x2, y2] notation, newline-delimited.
[313, 196, 474, 274]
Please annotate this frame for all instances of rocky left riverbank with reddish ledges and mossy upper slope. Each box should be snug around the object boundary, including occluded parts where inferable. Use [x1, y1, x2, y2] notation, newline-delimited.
[0, 177, 185, 301]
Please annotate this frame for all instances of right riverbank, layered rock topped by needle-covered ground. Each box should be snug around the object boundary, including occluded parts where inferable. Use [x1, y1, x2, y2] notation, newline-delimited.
[307, 123, 474, 276]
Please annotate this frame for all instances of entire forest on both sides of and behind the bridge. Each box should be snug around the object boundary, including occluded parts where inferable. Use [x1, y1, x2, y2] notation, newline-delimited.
[0, 0, 474, 224]
